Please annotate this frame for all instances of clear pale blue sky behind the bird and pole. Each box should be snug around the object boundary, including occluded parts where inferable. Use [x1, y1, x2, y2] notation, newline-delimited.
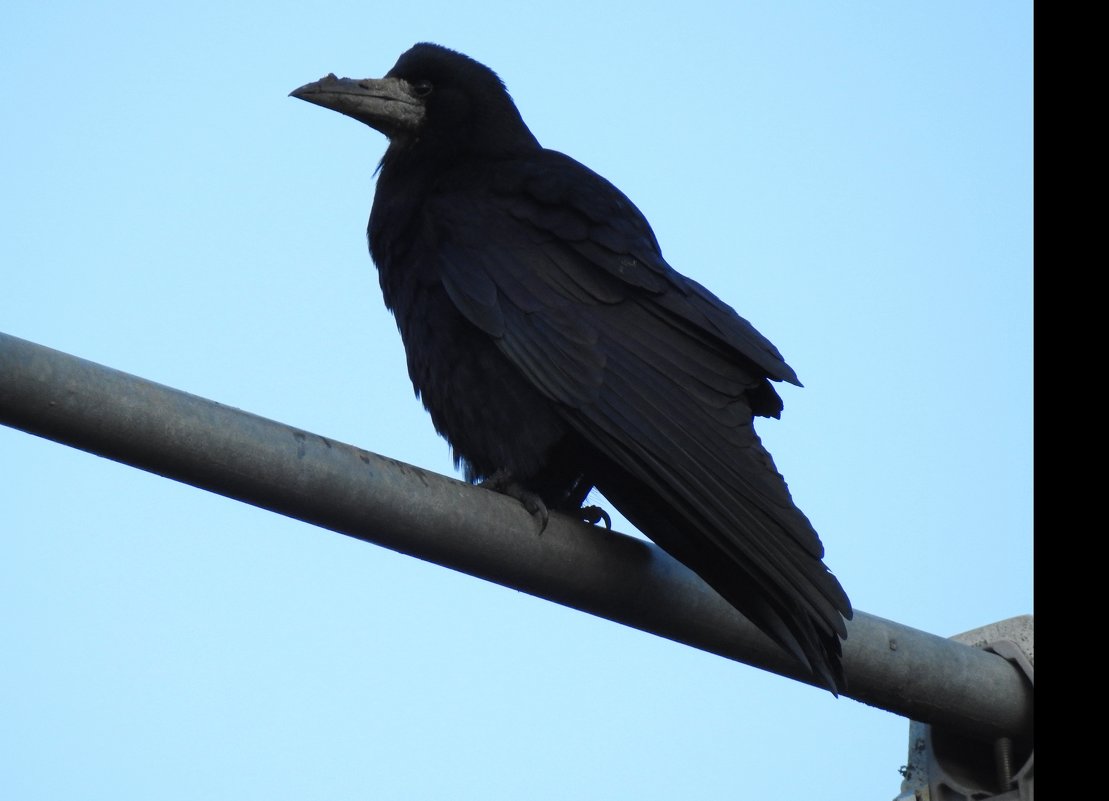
[0, 0, 1032, 801]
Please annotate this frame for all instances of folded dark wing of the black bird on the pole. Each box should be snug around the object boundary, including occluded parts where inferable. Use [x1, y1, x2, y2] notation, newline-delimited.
[426, 152, 851, 687]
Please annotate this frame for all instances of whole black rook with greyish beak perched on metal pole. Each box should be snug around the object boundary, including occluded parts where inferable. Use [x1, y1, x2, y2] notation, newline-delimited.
[293, 43, 852, 692]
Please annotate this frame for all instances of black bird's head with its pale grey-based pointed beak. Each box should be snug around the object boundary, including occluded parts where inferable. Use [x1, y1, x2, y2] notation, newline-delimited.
[292, 43, 539, 161]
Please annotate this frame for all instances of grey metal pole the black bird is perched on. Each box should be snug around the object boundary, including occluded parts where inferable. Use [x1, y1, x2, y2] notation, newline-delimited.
[0, 334, 1032, 740]
